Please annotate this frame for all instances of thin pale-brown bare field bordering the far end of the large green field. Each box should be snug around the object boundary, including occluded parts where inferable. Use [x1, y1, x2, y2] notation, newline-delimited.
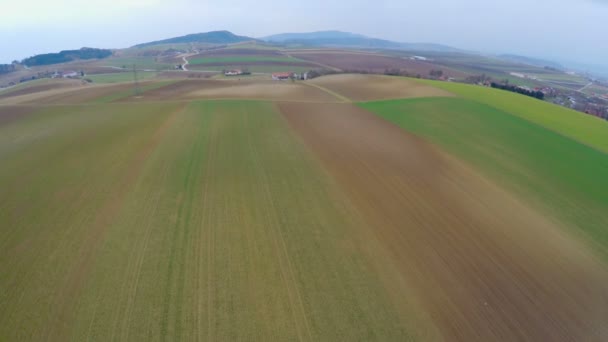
[122, 80, 340, 102]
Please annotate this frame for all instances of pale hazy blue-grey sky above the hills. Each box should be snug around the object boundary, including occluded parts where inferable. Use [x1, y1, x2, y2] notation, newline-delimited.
[0, 0, 608, 67]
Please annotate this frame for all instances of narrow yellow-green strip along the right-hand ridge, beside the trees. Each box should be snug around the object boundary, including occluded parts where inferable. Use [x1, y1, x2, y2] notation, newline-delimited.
[420, 80, 608, 152]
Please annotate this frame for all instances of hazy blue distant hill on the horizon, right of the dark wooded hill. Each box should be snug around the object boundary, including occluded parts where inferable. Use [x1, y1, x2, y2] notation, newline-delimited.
[261, 31, 462, 52]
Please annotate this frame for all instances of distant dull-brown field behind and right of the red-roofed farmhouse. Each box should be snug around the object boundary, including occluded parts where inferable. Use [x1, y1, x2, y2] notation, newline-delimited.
[289, 51, 466, 77]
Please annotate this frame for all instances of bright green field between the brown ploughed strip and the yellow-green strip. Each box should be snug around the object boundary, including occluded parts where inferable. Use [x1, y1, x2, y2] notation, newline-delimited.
[361, 94, 608, 257]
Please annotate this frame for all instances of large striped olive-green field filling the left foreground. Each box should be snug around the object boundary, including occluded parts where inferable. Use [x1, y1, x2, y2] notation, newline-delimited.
[0, 101, 412, 341]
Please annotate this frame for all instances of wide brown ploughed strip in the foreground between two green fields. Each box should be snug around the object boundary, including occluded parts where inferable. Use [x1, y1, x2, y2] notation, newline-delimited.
[280, 103, 608, 341]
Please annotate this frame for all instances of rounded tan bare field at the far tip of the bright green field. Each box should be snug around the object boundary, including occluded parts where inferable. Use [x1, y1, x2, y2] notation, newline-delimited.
[308, 75, 454, 101]
